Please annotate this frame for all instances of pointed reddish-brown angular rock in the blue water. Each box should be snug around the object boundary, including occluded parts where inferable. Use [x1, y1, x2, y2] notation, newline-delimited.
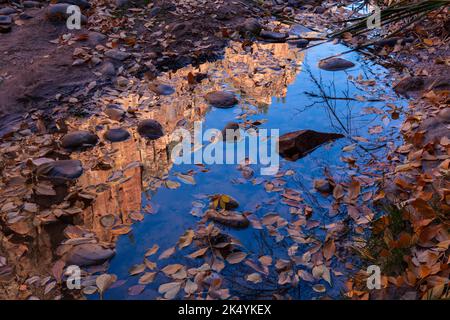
[279, 130, 344, 161]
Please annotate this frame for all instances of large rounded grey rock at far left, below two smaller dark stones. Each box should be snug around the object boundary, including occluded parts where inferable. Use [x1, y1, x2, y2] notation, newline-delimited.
[36, 160, 83, 183]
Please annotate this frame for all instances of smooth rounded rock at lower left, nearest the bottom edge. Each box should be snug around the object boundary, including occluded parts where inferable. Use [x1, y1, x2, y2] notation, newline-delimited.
[65, 243, 115, 267]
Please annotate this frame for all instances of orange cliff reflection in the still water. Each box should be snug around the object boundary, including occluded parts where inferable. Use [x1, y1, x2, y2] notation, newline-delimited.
[76, 43, 304, 242]
